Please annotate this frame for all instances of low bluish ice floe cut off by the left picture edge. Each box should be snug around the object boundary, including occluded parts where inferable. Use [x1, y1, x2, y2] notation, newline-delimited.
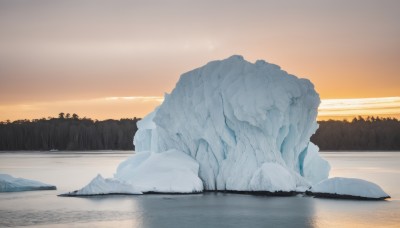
[0, 174, 56, 192]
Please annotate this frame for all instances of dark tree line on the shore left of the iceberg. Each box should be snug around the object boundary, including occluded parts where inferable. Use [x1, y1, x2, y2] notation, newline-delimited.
[0, 113, 139, 151]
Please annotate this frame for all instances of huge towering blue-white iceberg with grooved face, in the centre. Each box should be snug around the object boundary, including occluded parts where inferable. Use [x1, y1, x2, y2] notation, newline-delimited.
[69, 55, 330, 193]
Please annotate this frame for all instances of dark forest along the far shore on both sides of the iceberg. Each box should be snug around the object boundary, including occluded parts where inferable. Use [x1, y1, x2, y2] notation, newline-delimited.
[0, 113, 400, 151]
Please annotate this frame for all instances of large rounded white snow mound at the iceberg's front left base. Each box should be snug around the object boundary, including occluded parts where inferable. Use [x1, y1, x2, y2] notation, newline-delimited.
[115, 150, 203, 193]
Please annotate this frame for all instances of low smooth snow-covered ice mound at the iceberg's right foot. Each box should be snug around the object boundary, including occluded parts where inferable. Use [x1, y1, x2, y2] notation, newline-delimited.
[310, 177, 390, 199]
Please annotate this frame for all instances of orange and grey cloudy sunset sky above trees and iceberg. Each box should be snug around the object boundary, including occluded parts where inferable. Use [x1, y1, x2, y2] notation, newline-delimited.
[0, 0, 400, 121]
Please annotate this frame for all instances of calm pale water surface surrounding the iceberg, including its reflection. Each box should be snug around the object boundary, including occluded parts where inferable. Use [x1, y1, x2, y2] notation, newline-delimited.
[0, 152, 400, 228]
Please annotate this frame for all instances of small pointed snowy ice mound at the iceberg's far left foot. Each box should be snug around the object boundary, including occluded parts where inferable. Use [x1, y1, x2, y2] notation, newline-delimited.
[63, 174, 142, 196]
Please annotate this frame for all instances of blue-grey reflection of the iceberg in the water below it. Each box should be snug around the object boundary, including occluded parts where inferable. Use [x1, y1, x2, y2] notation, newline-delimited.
[134, 193, 314, 228]
